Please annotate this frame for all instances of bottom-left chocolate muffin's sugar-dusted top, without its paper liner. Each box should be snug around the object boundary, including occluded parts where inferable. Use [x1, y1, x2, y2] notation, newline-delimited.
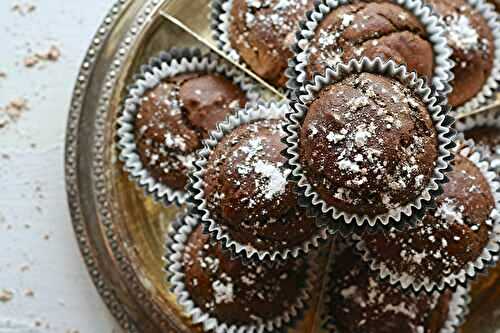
[182, 224, 308, 326]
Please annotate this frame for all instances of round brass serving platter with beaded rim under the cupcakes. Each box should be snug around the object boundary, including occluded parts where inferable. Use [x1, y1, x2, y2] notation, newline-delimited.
[66, 0, 500, 333]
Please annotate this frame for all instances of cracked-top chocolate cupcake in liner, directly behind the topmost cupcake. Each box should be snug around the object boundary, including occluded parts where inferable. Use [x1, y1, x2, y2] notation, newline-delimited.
[288, 0, 453, 94]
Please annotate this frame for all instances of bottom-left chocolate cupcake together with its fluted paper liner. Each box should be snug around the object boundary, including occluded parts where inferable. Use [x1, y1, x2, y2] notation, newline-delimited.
[167, 216, 314, 333]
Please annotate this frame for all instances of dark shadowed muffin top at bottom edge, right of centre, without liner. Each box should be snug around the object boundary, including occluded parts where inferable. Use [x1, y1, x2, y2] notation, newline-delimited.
[328, 244, 451, 333]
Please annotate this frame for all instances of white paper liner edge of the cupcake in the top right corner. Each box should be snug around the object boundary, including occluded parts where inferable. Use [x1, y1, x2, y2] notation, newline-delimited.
[455, 0, 500, 114]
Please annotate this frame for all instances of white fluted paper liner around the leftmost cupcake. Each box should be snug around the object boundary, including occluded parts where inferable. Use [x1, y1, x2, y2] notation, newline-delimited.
[118, 48, 259, 205]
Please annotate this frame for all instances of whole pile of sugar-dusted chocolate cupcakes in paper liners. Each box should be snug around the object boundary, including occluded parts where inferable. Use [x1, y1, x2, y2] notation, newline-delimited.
[118, 0, 500, 333]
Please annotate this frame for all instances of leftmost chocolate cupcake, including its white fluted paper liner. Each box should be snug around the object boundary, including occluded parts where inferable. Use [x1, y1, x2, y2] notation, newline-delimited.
[118, 50, 256, 204]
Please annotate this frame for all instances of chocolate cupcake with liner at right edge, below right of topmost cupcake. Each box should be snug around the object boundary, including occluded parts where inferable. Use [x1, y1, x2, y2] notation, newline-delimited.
[357, 148, 500, 291]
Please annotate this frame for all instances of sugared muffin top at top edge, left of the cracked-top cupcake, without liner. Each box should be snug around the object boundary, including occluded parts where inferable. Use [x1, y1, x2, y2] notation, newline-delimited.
[229, 0, 314, 87]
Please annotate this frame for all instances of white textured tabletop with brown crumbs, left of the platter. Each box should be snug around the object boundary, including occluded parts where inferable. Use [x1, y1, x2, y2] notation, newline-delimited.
[0, 0, 120, 333]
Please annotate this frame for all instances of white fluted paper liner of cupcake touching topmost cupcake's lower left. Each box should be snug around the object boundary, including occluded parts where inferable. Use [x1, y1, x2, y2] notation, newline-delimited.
[188, 101, 328, 261]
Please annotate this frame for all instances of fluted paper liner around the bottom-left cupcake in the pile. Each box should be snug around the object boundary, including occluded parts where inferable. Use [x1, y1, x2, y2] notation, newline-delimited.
[166, 216, 318, 333]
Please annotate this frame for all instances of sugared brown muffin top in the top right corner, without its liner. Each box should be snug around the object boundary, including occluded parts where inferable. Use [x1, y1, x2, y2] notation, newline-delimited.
[429, 0, 495, 107]
